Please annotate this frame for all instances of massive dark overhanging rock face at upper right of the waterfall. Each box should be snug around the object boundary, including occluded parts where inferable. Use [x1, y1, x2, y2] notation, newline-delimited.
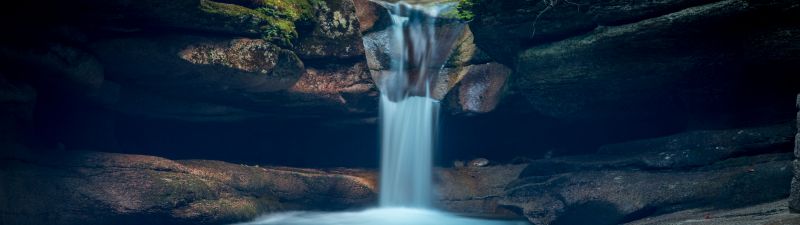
[462, 0, 800, 129]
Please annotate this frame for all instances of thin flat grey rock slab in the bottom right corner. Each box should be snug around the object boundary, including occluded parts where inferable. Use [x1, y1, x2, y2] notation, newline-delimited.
[625, 199, 800, 225]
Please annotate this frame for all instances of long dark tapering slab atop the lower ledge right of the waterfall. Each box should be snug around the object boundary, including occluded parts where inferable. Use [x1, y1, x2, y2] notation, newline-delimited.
[522, 124, 793, 176]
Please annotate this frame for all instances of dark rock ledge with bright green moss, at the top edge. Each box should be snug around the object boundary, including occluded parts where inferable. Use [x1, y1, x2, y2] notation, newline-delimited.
[88, 0, 317, 46]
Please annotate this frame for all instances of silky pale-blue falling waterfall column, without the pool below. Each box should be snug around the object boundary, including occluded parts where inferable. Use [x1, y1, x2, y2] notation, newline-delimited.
[378, 2, 455, 208]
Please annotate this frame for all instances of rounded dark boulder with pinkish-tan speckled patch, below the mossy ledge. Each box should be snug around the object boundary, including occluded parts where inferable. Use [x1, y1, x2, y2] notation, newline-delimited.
[92, 35, 326, 117]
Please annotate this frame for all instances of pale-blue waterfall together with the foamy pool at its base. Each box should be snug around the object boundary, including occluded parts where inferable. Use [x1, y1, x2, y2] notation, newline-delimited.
[236, 2, 527, 225]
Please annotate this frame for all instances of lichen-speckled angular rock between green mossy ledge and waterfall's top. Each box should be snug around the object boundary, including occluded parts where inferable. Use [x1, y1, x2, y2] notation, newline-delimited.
[294, 0, 364, 60]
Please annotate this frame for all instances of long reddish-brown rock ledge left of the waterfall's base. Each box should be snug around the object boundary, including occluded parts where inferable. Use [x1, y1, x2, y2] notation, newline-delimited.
[0, 152, 375, 224]
